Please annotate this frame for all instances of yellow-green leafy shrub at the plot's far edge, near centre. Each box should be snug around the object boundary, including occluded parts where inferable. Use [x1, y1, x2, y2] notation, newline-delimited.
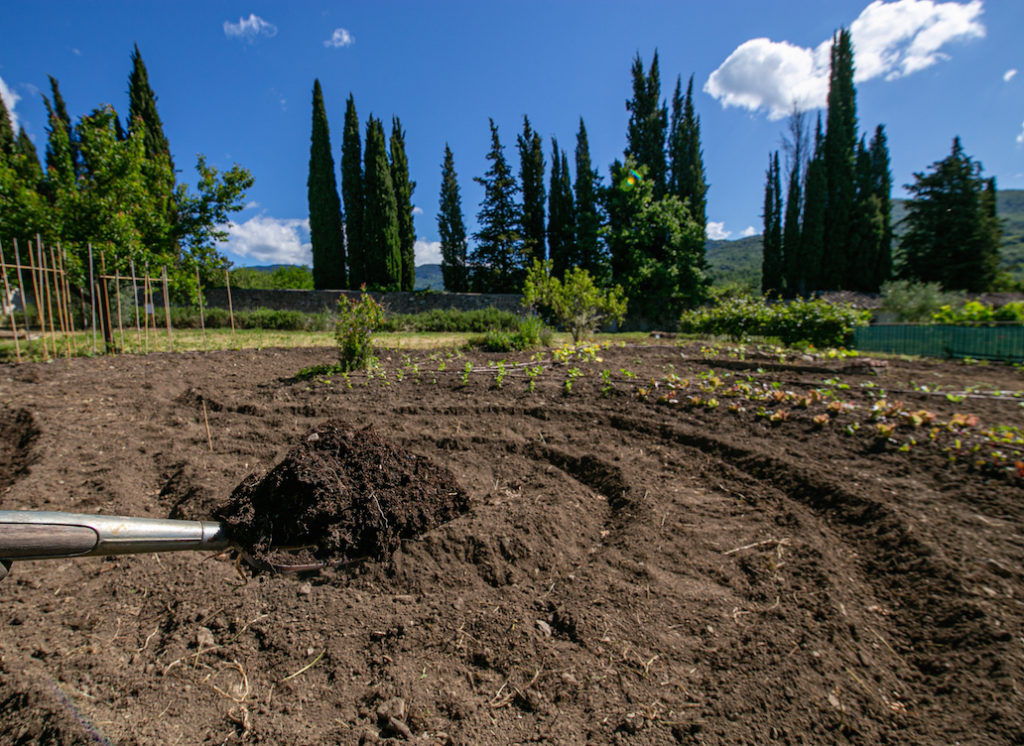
[522, 261, 626, 343]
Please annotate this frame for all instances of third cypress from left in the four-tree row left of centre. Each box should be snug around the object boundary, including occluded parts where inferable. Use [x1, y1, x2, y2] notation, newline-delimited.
[362, 116, 401, 290]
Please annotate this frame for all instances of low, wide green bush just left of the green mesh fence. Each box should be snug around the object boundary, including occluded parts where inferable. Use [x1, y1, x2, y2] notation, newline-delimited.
[679, 299, 870, 347]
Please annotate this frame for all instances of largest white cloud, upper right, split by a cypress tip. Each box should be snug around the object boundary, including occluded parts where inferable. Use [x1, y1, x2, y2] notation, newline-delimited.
[703, 0, 985, 120]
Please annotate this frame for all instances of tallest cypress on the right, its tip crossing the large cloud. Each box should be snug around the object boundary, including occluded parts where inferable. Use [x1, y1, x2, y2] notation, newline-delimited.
[822, 29, 857, 290]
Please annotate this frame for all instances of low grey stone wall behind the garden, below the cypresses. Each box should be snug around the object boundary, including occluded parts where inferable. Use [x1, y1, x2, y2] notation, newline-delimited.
[203, 288, 525, 313]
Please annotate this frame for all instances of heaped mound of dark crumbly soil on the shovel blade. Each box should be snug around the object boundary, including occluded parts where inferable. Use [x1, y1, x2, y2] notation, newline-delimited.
[216, 420, 469, 569]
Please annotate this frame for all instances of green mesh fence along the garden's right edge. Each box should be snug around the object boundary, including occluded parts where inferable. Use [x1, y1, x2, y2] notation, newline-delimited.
[853, 324, 1024, 361]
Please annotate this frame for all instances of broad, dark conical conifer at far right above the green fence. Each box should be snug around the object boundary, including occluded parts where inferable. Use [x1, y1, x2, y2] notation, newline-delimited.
[900, 137, 1001, 293]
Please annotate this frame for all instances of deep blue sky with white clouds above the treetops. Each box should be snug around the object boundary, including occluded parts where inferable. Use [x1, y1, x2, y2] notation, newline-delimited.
[0, 0, 1024, 265]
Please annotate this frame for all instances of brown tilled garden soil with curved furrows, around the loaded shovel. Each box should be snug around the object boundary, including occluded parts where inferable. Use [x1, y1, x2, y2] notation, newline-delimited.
[0, 346, 1024, 744]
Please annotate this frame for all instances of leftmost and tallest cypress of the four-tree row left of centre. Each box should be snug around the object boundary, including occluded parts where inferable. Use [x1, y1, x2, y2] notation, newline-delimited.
[306, 79, 348, 290]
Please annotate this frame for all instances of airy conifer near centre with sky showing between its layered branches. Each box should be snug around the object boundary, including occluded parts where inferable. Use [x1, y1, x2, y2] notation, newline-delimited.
[470, 119, 525, 293]
